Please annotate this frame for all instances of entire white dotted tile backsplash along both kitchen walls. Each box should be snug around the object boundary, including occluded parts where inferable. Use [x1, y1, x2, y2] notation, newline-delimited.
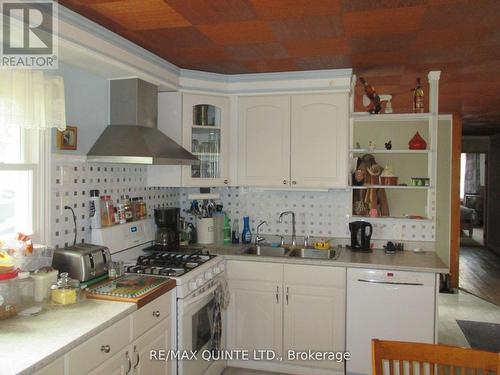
[51, 155, 435, 247]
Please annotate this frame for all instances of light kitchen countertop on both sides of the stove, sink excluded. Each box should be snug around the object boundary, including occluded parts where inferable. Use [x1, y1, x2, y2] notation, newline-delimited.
[0, 245, 448, 375]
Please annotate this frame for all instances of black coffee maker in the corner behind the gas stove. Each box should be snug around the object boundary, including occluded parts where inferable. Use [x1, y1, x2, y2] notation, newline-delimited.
[155, 207, 181, 251]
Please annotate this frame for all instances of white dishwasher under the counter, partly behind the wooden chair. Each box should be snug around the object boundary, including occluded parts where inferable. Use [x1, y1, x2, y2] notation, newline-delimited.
[346, 268, 436, 374]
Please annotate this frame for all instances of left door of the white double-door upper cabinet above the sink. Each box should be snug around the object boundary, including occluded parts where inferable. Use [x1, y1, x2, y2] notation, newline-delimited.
[238, 96, 290, 186]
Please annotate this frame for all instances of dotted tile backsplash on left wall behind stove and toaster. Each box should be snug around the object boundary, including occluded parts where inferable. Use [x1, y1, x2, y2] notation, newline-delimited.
[51, 156, 179, 247]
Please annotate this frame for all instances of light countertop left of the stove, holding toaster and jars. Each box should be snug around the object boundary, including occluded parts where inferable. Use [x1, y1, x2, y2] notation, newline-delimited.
[0, 299, 137, 375]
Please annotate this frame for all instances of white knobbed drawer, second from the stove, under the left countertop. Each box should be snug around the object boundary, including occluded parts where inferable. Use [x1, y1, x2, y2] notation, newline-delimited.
[67, 316, 130, 375]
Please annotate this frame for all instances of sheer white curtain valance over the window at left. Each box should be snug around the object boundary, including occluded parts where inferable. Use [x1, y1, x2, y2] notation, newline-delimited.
[0, 69, 66, 131]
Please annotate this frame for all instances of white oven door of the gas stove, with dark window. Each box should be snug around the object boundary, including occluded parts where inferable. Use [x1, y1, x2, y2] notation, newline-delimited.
[177, 279, 224, 375]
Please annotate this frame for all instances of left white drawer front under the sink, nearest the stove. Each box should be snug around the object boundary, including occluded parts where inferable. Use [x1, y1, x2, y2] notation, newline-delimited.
[226, 260, 283, 283]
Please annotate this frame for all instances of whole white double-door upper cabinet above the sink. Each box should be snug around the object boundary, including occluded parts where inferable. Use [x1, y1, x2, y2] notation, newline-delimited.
[238, 93, 349, 188]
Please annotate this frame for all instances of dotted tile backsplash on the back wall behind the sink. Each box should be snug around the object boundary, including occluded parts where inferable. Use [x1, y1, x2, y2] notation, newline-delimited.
[180, 187, 435, 242]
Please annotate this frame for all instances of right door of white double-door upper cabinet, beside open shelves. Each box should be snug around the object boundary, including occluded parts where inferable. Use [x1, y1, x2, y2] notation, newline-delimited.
[290, 94, 349, 188]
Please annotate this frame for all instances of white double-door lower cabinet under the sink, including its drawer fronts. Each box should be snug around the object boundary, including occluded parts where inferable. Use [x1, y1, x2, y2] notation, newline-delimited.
[227, 261, 346, 374]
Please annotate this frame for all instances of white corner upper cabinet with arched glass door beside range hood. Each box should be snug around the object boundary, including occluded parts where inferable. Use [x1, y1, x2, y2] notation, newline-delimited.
[182, 94, 229, 187]
